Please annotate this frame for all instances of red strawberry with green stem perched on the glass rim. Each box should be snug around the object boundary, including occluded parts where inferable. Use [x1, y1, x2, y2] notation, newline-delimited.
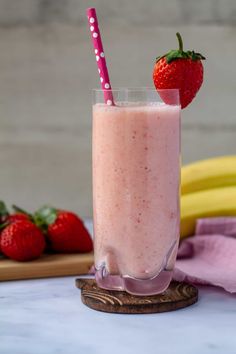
[153, 33, 205, 108]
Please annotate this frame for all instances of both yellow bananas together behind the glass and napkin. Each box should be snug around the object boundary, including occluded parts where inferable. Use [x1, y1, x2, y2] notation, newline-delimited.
[181, 156, 236, 238]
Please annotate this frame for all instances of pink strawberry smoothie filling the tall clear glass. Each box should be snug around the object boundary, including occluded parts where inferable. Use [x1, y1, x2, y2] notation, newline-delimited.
[93, 103, 180, 279]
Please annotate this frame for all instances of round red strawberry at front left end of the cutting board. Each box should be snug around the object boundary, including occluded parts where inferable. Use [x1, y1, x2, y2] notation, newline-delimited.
[0, 220, 45, 262]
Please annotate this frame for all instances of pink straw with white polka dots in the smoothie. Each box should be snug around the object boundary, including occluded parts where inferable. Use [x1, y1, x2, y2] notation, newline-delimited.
[87, 8, 114, 106]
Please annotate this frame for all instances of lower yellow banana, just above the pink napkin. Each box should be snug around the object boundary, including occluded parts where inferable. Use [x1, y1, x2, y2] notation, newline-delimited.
[180, 186, 236, 238]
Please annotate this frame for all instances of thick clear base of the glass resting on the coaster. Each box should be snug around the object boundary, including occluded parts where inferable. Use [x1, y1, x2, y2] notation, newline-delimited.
[95, 266, 173, 296]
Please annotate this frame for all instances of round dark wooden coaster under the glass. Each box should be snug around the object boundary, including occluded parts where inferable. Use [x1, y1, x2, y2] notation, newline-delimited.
[76, 278, 198, 314]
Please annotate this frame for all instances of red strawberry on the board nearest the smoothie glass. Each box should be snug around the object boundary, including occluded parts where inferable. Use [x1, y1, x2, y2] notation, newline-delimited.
[34, 207, 93, 252]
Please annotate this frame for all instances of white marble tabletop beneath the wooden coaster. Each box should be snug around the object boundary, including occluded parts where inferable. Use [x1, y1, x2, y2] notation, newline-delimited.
[0, 277, 236, 354]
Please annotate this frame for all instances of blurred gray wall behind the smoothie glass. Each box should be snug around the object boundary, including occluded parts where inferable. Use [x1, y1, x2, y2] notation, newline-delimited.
[0, 0, 236, 217]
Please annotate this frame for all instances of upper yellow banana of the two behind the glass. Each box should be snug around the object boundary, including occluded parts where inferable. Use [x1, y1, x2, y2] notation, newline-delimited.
[181, 155, 236, 195]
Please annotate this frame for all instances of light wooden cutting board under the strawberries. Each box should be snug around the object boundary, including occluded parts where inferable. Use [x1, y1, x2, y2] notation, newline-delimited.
[0, 253, 93, 281]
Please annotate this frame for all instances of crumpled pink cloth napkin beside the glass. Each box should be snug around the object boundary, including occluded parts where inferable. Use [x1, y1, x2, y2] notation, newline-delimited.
[174, 217, 236, 293]
